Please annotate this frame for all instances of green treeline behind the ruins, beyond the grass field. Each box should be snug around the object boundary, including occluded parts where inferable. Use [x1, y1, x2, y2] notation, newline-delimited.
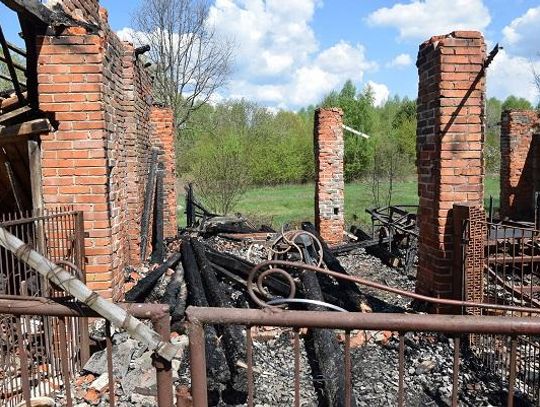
[177, 81, 532, 209]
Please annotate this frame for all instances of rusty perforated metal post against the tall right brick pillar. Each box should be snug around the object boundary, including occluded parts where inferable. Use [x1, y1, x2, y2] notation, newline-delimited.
[452, 203, 487, 315]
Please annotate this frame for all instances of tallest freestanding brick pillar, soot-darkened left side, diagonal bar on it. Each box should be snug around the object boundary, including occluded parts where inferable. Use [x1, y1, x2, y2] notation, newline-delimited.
[416, 31, 486, 306]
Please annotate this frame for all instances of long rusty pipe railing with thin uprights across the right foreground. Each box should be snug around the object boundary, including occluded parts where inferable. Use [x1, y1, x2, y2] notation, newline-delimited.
[187, 307, 540, 407]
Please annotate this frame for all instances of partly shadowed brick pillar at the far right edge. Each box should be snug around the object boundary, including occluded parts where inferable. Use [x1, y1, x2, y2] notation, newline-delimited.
[500, 110, 540, 221]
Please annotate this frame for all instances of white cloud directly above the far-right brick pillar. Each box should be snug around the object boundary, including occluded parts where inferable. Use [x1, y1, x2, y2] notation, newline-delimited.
[486, 50, 540, 104]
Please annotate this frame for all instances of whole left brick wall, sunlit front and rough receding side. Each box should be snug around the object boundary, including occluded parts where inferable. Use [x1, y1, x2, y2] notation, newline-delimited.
[37, 1, 176, 299]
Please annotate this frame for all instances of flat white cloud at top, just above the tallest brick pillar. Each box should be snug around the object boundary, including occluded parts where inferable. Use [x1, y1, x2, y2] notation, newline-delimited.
[367, 0, 491, 40]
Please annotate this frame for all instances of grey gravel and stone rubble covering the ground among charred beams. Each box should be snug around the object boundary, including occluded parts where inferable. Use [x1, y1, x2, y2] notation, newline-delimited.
[68, 231, 532, 407]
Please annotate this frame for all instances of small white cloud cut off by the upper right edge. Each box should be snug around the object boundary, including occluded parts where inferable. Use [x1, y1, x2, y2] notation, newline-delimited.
[503, 6, 540, 58]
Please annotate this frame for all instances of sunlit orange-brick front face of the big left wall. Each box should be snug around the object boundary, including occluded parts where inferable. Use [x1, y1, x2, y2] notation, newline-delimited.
[37, 27, 113, 297]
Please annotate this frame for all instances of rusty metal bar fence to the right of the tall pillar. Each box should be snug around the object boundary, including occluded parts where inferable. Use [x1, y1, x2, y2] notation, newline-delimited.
[464, 220, 540, 402]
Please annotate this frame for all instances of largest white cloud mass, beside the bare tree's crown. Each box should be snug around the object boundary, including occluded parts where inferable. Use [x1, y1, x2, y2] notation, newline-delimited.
[210, 0, 377, 108]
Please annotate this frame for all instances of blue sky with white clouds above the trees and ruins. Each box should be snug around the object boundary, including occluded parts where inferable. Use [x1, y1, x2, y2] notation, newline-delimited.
[0, 0, 540, 109]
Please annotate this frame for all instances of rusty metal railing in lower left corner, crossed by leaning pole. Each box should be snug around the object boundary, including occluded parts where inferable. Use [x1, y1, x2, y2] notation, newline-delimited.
[0, 298, 173, 407]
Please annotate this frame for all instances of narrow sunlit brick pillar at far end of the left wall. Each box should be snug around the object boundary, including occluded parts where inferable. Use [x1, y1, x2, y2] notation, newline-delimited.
[150, 106, 178, 238]
